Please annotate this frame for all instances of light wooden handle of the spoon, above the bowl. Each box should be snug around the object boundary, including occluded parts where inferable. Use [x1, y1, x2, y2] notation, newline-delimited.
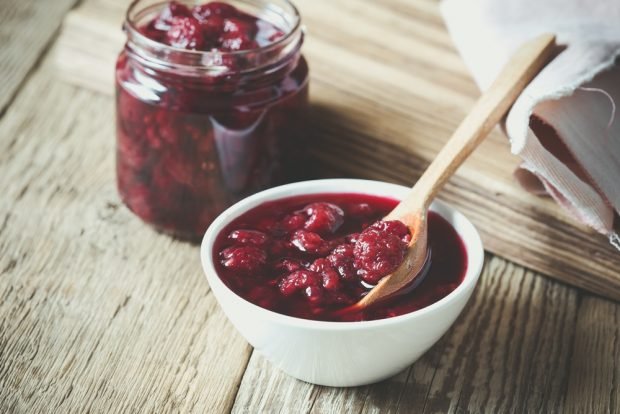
[389, 33, 555, 218]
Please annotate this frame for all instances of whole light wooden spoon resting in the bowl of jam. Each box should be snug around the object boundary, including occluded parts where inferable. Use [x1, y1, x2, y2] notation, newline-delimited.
[353, 34, 555, 309]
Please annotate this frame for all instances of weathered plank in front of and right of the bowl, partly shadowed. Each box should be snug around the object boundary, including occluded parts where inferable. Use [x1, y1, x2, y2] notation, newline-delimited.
[233, 258, 584, 413]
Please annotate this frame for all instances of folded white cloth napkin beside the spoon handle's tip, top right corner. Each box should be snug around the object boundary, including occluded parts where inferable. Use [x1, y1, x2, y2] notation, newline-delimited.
[441, 0, 620, 250]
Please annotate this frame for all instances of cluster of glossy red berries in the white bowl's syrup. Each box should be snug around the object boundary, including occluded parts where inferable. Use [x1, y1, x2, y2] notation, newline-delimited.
[219, 202, 411, 305]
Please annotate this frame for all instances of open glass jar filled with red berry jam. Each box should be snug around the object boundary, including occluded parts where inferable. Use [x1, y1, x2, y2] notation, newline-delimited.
[116, 0, 308, 240]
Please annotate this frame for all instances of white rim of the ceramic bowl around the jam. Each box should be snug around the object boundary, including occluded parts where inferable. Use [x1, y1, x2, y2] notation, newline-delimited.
[200, 178, 484, 331]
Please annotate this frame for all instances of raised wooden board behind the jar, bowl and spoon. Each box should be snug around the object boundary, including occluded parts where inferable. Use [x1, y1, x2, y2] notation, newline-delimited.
[50, 0, 620, 300]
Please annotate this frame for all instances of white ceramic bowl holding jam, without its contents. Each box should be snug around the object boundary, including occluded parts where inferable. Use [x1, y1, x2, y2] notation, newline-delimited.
[201, 179, 484, 386]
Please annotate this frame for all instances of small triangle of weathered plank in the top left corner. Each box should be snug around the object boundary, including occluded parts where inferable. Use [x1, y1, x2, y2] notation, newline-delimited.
[0, 0, 78, 114]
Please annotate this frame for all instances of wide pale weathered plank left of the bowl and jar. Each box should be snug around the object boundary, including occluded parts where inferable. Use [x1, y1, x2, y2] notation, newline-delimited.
[0, 56, 250, 412]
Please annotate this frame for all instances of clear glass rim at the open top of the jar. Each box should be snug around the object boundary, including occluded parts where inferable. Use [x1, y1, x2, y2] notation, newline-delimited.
[123, 0, 303, 62]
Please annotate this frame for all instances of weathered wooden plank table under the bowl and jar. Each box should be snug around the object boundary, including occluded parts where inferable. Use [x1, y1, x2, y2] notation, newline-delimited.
[0, 0, 620, 413]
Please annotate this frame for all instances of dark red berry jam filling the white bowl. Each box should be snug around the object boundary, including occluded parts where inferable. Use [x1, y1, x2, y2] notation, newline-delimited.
[213, 194, 467, 321]
